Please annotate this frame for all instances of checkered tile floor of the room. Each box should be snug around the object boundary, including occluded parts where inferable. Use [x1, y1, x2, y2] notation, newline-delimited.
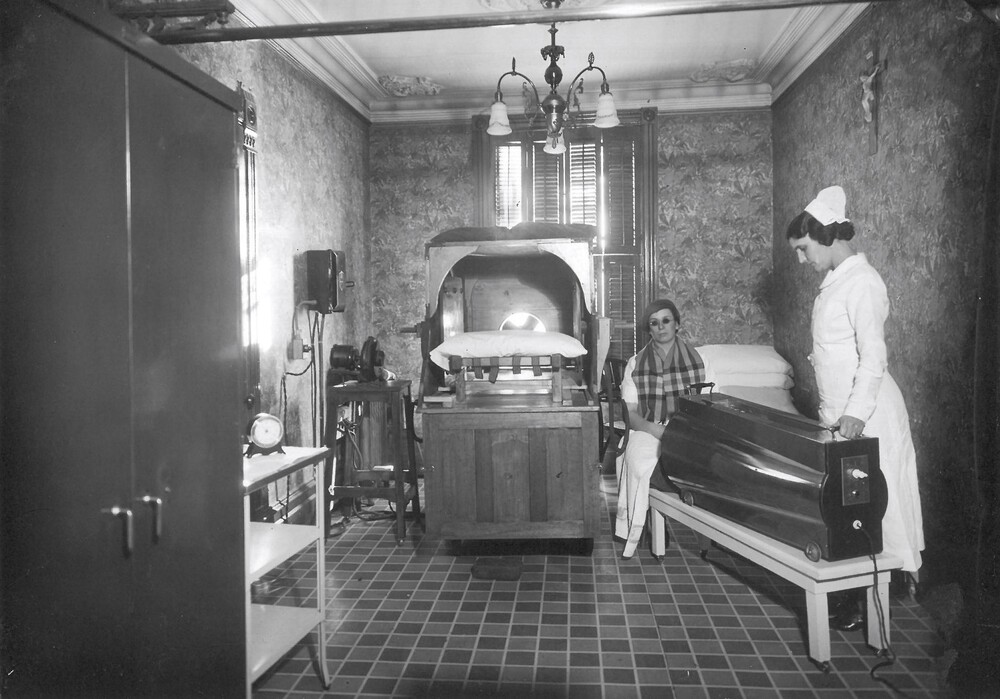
[254, 476, 951, 699]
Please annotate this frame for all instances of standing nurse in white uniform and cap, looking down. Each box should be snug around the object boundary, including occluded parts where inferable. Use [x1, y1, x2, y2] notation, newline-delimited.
[787, 187, 924, 629]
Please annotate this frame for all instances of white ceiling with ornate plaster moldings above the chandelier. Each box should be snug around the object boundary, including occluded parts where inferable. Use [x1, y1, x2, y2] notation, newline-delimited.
[232, 0, 869, 124]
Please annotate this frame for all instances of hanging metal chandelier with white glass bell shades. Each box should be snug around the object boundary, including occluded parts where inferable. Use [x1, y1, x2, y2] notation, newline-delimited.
[486, 0, 621, 154]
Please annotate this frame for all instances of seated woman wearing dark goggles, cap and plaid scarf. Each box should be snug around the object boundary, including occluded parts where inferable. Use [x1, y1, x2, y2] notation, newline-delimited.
[615, 299, 705, 558]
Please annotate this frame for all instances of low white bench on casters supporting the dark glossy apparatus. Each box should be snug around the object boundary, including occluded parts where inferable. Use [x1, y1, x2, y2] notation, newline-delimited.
[649, 490, 903, 672]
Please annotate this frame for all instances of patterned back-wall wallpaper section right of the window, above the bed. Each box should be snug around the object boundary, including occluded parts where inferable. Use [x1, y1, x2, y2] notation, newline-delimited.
[654, 111, 771, 345]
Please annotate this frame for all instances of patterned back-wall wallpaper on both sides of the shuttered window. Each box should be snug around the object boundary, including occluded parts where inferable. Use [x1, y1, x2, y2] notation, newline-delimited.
[371, 112, 771, 386]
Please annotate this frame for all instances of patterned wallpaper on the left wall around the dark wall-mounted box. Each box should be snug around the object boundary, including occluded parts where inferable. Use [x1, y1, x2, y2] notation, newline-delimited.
[178, 42, 371, 446]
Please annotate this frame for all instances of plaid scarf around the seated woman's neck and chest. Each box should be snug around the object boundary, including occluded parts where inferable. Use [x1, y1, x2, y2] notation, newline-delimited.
[632, 337, 705, 424]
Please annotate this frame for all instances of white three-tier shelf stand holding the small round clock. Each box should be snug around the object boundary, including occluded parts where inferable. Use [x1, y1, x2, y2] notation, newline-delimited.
[243, 447, 333, 698]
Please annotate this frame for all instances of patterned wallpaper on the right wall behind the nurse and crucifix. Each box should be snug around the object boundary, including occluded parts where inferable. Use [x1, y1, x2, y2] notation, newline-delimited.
[773, 0, 998, 580]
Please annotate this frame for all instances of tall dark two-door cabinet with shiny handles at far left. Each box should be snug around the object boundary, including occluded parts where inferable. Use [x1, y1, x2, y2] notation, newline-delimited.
[0, 0, 246, 696]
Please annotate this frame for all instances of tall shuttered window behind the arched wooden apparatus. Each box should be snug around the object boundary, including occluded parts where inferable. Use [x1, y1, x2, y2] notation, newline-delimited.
[477, 110, 657, 359]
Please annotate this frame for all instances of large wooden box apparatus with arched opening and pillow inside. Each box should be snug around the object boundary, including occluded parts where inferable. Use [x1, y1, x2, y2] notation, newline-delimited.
[419, 226, 600, 544]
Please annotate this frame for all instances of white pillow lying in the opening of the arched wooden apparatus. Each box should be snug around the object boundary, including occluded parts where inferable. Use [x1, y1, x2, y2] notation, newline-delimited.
[431, 330, 587, 369]
